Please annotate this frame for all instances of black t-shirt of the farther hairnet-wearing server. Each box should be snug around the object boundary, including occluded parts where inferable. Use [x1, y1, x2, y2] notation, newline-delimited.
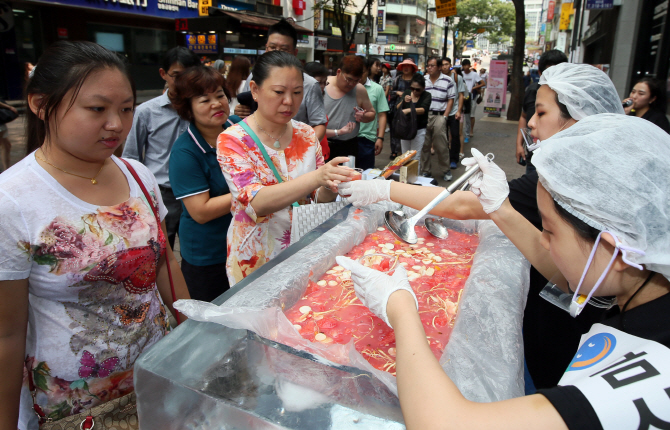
[509, 171, 616, 389]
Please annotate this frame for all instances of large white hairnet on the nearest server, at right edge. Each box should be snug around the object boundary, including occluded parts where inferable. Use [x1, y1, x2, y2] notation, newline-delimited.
[533, 114, 670, 279]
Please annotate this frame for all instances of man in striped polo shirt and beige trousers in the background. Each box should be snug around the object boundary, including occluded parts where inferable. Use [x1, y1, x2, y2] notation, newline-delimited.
[421, 57, 460, 181]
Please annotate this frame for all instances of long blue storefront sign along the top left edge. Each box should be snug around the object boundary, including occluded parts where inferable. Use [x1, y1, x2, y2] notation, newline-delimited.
[40, 0, 200, 19]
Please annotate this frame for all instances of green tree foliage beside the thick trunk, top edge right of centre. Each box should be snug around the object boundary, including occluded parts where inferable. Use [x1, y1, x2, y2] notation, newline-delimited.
[449, 0, 515, 53]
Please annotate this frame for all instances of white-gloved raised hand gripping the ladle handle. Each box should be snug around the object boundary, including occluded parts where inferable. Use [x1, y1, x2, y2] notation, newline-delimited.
[462, 148, 509, 214]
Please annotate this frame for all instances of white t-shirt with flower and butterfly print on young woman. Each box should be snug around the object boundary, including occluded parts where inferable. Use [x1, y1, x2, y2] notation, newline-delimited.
[0, 154, 168, 430]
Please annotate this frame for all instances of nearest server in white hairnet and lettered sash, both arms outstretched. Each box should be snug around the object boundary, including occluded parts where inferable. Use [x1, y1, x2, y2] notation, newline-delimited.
[337, 114, 670, 430]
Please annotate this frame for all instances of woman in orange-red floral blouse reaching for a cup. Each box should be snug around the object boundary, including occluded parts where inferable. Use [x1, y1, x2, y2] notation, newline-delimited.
[217, 51, 354, 286]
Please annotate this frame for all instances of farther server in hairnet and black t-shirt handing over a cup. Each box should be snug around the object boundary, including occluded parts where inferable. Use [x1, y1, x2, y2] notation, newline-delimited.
[340, 63, 624, 388]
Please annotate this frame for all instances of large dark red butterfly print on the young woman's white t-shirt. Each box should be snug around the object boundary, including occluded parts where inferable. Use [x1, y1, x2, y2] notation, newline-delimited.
[84, 239, 165, 294]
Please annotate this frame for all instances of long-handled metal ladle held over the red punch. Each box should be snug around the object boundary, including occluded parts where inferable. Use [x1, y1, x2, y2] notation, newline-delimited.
[384, 154, 493, 244]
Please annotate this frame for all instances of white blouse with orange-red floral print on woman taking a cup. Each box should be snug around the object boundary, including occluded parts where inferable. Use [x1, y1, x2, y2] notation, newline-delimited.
[217, 120, 324, 285]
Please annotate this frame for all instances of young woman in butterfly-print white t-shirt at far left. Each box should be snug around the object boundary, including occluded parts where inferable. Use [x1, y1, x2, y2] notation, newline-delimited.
[0, 42, 188, 430]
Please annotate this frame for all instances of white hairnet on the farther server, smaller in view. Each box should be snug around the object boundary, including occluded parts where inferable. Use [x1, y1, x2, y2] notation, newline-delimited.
[540, 63, 624, 121]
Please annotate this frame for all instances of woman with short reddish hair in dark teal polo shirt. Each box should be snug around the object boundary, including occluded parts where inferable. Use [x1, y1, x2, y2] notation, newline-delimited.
[169, 66, 240, 302]
